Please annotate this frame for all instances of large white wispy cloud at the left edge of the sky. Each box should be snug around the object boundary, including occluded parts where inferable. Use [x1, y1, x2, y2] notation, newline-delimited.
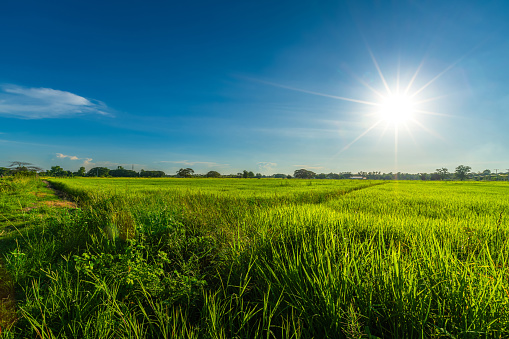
[0, 85, 112, 119]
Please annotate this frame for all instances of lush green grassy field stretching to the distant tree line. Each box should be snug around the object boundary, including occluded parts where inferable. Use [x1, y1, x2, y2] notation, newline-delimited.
[0, 178, 509, 338]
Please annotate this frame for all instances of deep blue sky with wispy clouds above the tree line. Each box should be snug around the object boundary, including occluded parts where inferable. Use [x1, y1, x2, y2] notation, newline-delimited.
[0, 1, 509, 174]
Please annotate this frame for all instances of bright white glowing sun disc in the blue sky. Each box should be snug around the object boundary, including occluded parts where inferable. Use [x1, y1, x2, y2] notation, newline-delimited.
[378, 94, 415, 126]
